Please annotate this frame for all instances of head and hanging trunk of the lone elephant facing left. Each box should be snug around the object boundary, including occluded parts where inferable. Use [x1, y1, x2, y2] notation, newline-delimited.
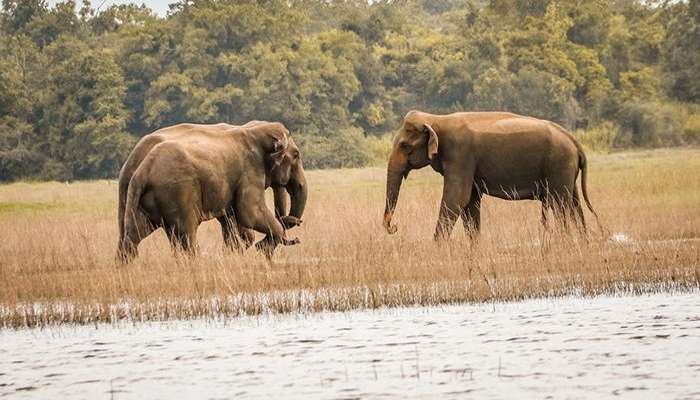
[384, 111, 438, 234]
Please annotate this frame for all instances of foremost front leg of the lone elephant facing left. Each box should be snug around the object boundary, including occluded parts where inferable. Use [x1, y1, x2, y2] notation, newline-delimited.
[435, 173, 472, 241]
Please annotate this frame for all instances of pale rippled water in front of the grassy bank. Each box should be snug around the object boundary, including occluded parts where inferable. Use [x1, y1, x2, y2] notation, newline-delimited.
[0, 292, 700, 399]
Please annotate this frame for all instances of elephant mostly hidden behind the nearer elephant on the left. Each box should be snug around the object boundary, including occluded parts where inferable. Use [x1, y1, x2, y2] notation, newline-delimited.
[118, 120, 306, 257]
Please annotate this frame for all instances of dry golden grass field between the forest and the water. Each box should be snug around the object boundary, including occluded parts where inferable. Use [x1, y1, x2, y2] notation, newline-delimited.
[0, 149, 700, 328]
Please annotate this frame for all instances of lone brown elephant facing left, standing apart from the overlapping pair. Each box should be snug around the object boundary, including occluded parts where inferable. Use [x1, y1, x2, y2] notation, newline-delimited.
[383, 110, 600, 241]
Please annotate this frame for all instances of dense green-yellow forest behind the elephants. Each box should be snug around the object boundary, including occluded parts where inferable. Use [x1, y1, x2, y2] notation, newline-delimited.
[0, 0, 700, 181]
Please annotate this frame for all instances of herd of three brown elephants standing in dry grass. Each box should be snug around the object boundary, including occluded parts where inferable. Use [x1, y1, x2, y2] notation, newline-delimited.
[118, 111, 598, 262]
